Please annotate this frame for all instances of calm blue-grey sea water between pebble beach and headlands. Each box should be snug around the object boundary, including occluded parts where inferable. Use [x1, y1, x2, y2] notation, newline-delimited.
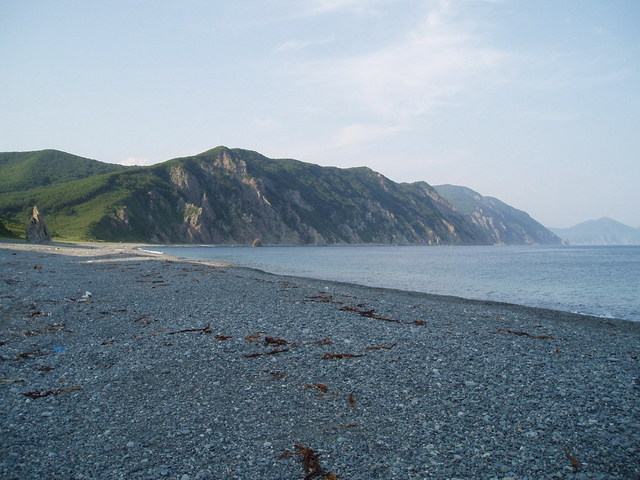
[155, 246, 640, 321]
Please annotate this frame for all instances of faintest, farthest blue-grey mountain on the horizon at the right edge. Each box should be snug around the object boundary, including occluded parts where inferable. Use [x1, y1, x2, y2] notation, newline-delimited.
[550, 217, 640, 245]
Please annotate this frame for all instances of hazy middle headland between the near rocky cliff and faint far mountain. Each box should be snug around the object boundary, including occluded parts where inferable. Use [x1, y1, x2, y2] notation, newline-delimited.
[434, 185, 560, 244]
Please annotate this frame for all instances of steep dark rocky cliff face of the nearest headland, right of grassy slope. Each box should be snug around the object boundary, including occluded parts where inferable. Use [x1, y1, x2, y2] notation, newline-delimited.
[132, 148, 477, 245]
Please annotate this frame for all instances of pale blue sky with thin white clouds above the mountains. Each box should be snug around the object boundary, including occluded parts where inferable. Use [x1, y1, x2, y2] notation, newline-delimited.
[0, 0, 640, 227]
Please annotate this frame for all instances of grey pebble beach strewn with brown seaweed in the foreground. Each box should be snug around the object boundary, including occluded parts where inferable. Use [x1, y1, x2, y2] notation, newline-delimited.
[0, 243, 640, 480]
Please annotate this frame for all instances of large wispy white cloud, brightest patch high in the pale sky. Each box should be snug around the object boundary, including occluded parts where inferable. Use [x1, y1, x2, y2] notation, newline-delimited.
[291, 2, 506, 120]
